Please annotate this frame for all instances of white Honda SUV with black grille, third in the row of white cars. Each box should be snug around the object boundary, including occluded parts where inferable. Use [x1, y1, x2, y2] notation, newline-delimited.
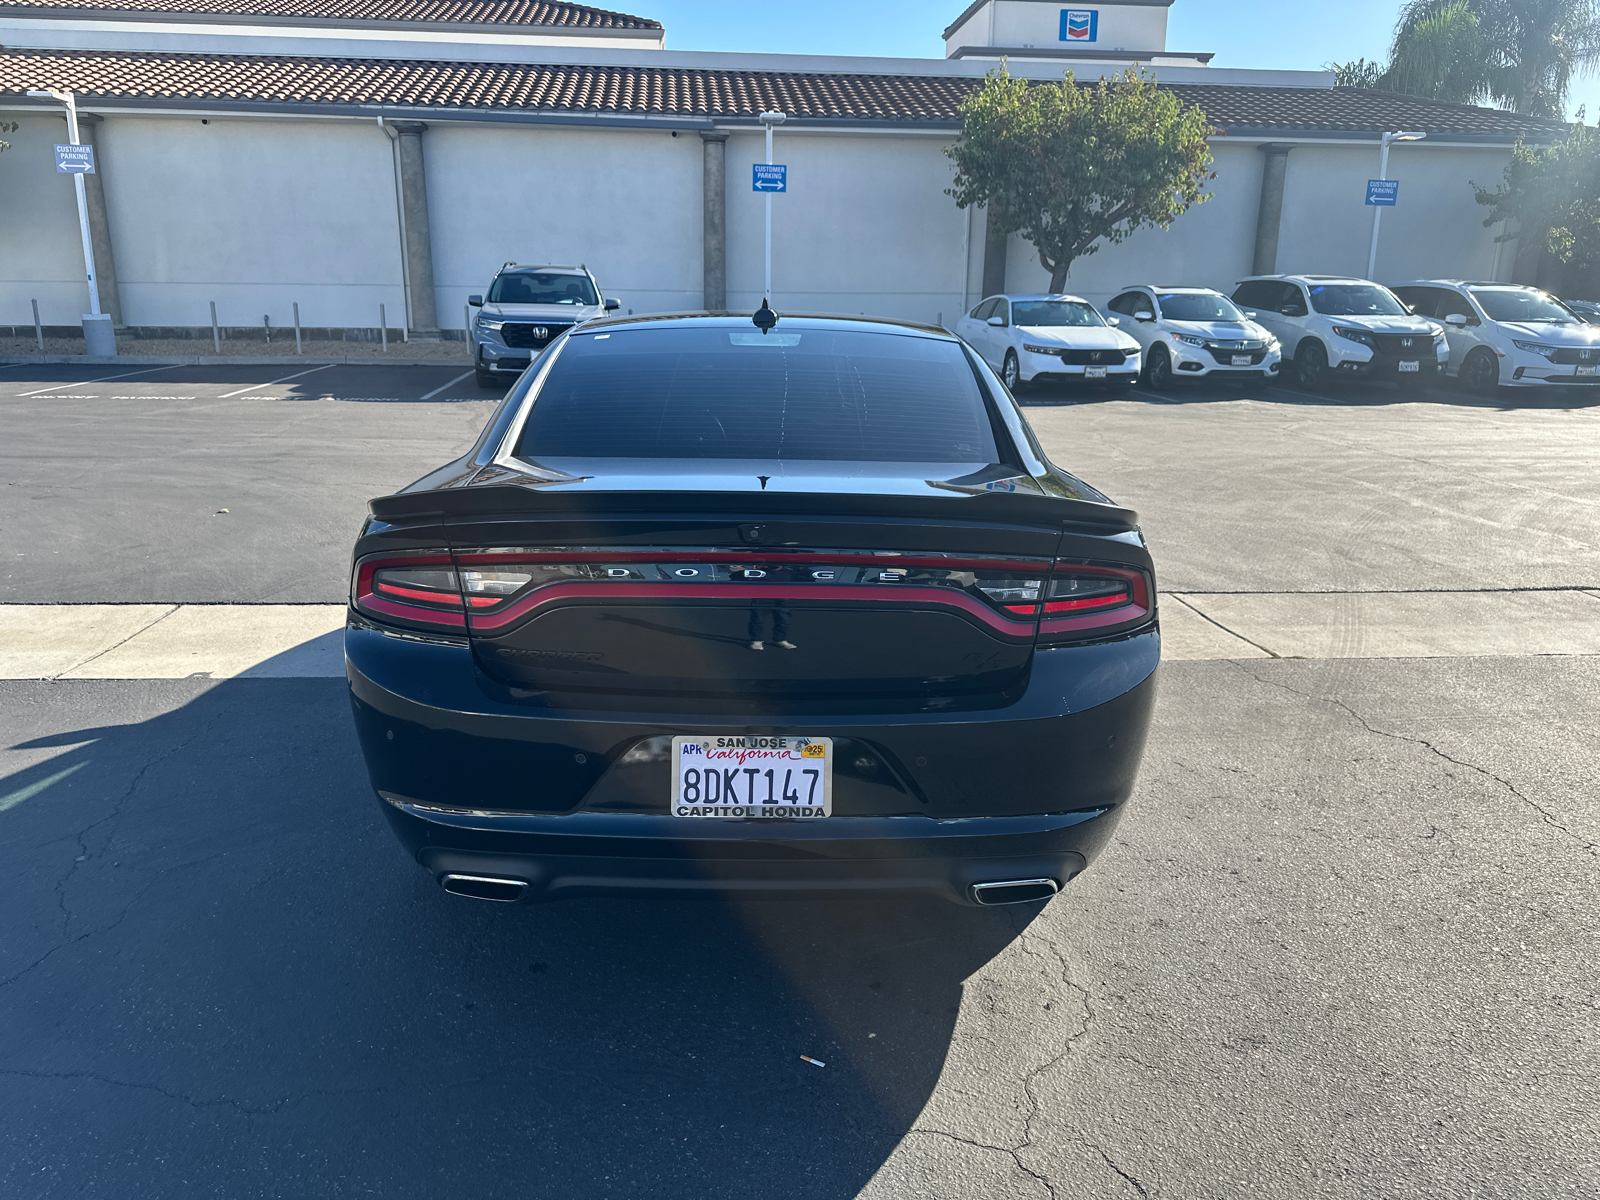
[1234, 275, 1450, 389]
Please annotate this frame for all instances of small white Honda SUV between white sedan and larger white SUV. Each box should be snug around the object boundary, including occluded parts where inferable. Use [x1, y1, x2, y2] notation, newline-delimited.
[1106, 283, 1283, 387]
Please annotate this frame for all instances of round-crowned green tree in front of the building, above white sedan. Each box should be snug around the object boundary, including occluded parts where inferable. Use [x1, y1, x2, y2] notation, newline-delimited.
[946, 64, 1216, 291]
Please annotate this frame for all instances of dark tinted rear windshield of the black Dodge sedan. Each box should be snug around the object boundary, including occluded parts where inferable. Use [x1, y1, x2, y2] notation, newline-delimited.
[517, 326, 1000, 462]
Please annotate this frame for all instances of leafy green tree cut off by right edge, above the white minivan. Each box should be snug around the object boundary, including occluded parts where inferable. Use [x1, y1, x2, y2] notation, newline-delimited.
[1472, 125, 1600, 280]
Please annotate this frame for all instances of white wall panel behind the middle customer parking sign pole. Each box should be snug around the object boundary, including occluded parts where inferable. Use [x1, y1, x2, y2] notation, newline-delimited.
[728, 130, 982, 323]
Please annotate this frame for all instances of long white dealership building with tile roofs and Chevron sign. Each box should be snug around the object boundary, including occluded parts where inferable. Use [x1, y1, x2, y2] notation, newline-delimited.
[0, 0, 1565, 336]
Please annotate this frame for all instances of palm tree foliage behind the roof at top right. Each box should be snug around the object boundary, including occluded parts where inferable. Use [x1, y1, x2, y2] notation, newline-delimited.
[1328, 0, 1600, 117]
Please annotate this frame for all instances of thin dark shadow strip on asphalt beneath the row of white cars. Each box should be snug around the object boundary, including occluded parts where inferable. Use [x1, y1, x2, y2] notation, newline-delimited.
[1016, 379, 1600, 413]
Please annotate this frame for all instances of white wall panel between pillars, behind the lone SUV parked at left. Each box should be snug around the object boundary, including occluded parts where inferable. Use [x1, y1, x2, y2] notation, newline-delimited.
[422, 122, 702, 328]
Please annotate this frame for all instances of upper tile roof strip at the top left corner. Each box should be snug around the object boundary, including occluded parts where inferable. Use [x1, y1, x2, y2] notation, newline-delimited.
[0, 0, 661, 30]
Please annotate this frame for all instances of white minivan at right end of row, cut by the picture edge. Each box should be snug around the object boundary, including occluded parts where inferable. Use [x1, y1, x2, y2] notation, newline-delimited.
[1394, 278, 1600, 392]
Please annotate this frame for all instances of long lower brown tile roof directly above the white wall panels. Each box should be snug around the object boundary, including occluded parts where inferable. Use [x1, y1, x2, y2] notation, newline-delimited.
[0, 50, 1566, 142]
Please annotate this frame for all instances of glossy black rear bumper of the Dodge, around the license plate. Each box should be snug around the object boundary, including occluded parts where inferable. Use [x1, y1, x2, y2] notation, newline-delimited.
[346, 626, 1160, 902]
